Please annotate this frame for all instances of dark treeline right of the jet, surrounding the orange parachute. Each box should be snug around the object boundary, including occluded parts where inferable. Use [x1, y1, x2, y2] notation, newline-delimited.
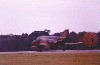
[54, 31, 100, 50]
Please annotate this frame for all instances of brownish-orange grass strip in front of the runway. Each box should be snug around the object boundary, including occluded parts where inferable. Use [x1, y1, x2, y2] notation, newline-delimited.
[0, 53, 100, 65]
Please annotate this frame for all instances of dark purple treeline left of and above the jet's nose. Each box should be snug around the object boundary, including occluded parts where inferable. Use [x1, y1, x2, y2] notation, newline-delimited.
[0, 30, 49, 52]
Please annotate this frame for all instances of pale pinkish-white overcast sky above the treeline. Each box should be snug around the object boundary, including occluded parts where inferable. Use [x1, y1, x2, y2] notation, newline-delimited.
[0, 0, 100, 34]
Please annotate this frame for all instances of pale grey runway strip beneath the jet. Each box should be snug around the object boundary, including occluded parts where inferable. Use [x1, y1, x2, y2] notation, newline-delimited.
[0, 50, 100, 54]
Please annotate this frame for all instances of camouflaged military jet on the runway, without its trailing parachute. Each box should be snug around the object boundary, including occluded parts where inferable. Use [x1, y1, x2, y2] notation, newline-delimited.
[32, 29, 69, 51]
